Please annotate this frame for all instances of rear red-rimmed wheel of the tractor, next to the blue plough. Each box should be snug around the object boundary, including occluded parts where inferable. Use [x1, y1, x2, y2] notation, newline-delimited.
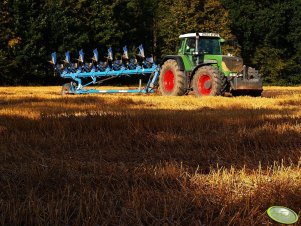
[159, 60, 185, 96]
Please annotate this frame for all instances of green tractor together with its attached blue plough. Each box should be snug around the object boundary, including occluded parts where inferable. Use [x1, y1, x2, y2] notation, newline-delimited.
[52, 33, 262, 96]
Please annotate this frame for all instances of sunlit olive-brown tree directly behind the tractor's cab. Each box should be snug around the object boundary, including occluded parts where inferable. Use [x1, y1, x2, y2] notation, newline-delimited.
[157, 0, 239, 58]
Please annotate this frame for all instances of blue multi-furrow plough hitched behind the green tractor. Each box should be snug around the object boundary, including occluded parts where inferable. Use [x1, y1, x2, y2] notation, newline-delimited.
[51, 45, 160, 95]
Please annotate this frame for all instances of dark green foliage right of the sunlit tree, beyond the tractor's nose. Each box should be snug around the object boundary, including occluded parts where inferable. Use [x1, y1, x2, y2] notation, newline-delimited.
[222, 0, 301, 85]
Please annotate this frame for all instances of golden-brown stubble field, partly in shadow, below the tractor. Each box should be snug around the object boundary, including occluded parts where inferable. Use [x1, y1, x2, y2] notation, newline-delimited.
[0, 87, 301, 225]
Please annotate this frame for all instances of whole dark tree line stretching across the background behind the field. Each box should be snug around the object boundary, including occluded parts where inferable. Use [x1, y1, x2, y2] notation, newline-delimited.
[0, 0, 301, 85]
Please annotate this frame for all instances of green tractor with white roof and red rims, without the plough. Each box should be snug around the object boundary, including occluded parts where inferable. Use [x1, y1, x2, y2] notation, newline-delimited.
[159, 33, 262, 96]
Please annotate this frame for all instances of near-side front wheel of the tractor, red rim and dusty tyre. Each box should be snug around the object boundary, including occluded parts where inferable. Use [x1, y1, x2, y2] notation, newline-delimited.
[192, 66, 228, 96]
